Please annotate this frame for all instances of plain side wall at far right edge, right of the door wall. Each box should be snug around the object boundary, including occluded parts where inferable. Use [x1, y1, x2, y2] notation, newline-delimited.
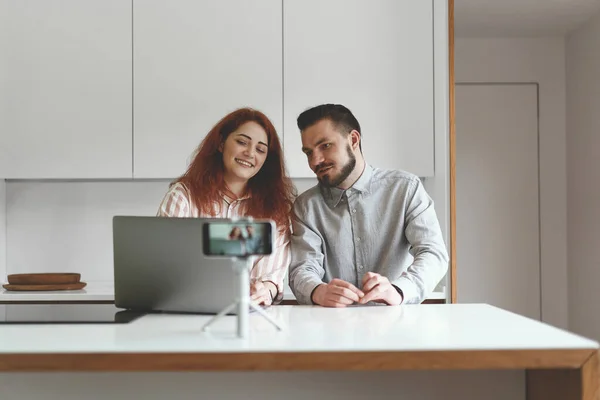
[566, 10, 600, 340]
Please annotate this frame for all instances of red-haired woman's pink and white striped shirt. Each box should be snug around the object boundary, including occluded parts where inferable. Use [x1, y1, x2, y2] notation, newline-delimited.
[157, 182, 290, 303]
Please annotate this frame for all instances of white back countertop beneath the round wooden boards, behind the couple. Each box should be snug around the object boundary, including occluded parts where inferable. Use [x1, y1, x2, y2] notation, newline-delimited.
[0, 282, 446, 303]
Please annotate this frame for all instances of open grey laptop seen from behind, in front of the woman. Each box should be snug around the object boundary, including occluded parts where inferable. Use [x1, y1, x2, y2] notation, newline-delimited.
[113, 216, 237, 314]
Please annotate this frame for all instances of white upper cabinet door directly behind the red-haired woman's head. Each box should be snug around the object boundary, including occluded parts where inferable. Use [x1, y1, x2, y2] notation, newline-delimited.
[133, 0, 283, 178]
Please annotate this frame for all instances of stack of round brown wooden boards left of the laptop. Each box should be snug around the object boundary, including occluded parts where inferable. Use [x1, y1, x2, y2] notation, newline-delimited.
[2, 272, 87, 291]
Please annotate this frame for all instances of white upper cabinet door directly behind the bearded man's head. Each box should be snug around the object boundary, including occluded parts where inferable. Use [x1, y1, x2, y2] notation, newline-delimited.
[283, 0, 434, 177]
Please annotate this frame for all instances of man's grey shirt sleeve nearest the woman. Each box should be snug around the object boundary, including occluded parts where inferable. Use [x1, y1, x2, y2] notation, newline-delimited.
[289, 202, 325, 304]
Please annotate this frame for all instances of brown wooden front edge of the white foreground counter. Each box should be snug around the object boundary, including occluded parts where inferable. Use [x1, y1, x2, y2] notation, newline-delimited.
[0, 349, 598, 372]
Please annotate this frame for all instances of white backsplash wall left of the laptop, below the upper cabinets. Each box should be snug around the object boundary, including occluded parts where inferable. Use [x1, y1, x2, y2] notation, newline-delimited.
[6, 181, 168, 282]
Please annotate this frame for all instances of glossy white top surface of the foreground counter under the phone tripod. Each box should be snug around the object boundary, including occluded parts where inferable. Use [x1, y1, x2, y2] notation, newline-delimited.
[0, 304, 598, 355]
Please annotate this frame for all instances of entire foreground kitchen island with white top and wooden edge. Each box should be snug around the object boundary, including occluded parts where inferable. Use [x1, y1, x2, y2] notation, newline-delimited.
[0, 304, 600, 400]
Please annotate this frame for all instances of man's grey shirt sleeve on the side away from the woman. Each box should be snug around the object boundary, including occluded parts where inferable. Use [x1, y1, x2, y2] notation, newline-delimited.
[392, 180, 449, 304]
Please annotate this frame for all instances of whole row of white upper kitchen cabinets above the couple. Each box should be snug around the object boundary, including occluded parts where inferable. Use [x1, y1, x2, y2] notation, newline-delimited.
[0, 0, 440, 179]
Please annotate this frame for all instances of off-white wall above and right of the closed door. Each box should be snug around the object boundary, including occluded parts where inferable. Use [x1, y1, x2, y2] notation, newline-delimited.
[455, 38, 568, 328]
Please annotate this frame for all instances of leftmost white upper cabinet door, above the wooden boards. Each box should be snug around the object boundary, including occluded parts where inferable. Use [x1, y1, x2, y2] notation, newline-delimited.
[0, 0, 132, 178]
